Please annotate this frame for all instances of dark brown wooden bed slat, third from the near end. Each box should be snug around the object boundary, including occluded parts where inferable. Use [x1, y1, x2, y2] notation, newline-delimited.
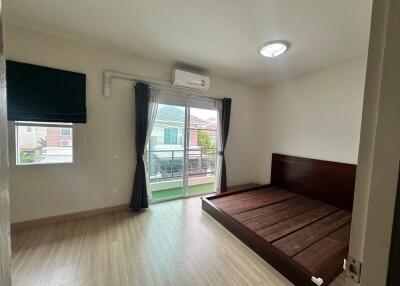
[257, 203, 339, 242]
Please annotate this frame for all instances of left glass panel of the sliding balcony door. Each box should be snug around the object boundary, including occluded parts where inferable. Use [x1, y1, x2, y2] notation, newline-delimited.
[147, 104, 185, 201]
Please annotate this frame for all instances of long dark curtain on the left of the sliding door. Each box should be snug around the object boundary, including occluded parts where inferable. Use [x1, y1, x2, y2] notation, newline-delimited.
[130, 83, 150, 212]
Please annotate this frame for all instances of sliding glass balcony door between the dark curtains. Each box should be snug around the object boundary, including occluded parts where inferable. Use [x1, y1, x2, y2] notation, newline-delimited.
[147, 104, 217, 202]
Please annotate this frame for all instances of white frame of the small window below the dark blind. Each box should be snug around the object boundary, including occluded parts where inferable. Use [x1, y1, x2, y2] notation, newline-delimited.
[10, 121, 76, 165]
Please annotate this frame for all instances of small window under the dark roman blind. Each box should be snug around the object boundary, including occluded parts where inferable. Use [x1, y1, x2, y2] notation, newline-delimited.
[15, 121, 73, 165]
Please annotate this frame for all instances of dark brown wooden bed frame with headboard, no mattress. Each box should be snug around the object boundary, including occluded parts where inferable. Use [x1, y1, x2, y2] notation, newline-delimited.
[202, 154, 356, 286]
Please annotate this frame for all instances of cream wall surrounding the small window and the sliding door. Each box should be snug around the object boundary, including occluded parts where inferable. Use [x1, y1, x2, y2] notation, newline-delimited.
[5, 25, 257, 222]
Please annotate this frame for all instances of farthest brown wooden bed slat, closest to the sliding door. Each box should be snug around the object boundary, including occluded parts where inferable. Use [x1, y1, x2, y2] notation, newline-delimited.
[222, 190, 296, 215]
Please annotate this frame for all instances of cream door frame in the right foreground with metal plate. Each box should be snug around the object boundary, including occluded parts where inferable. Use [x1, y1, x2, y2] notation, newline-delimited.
[346, 0, 400, 286]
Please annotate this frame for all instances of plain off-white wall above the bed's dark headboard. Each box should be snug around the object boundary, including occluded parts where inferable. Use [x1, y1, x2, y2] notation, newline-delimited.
[257, 61, 366, 183]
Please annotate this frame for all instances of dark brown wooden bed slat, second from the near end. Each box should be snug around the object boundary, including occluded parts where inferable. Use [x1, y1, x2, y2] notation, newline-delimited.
[273, 210, 351, 256]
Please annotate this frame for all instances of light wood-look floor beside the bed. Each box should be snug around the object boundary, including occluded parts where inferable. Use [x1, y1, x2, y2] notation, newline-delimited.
[12, 198, 344, 286]
